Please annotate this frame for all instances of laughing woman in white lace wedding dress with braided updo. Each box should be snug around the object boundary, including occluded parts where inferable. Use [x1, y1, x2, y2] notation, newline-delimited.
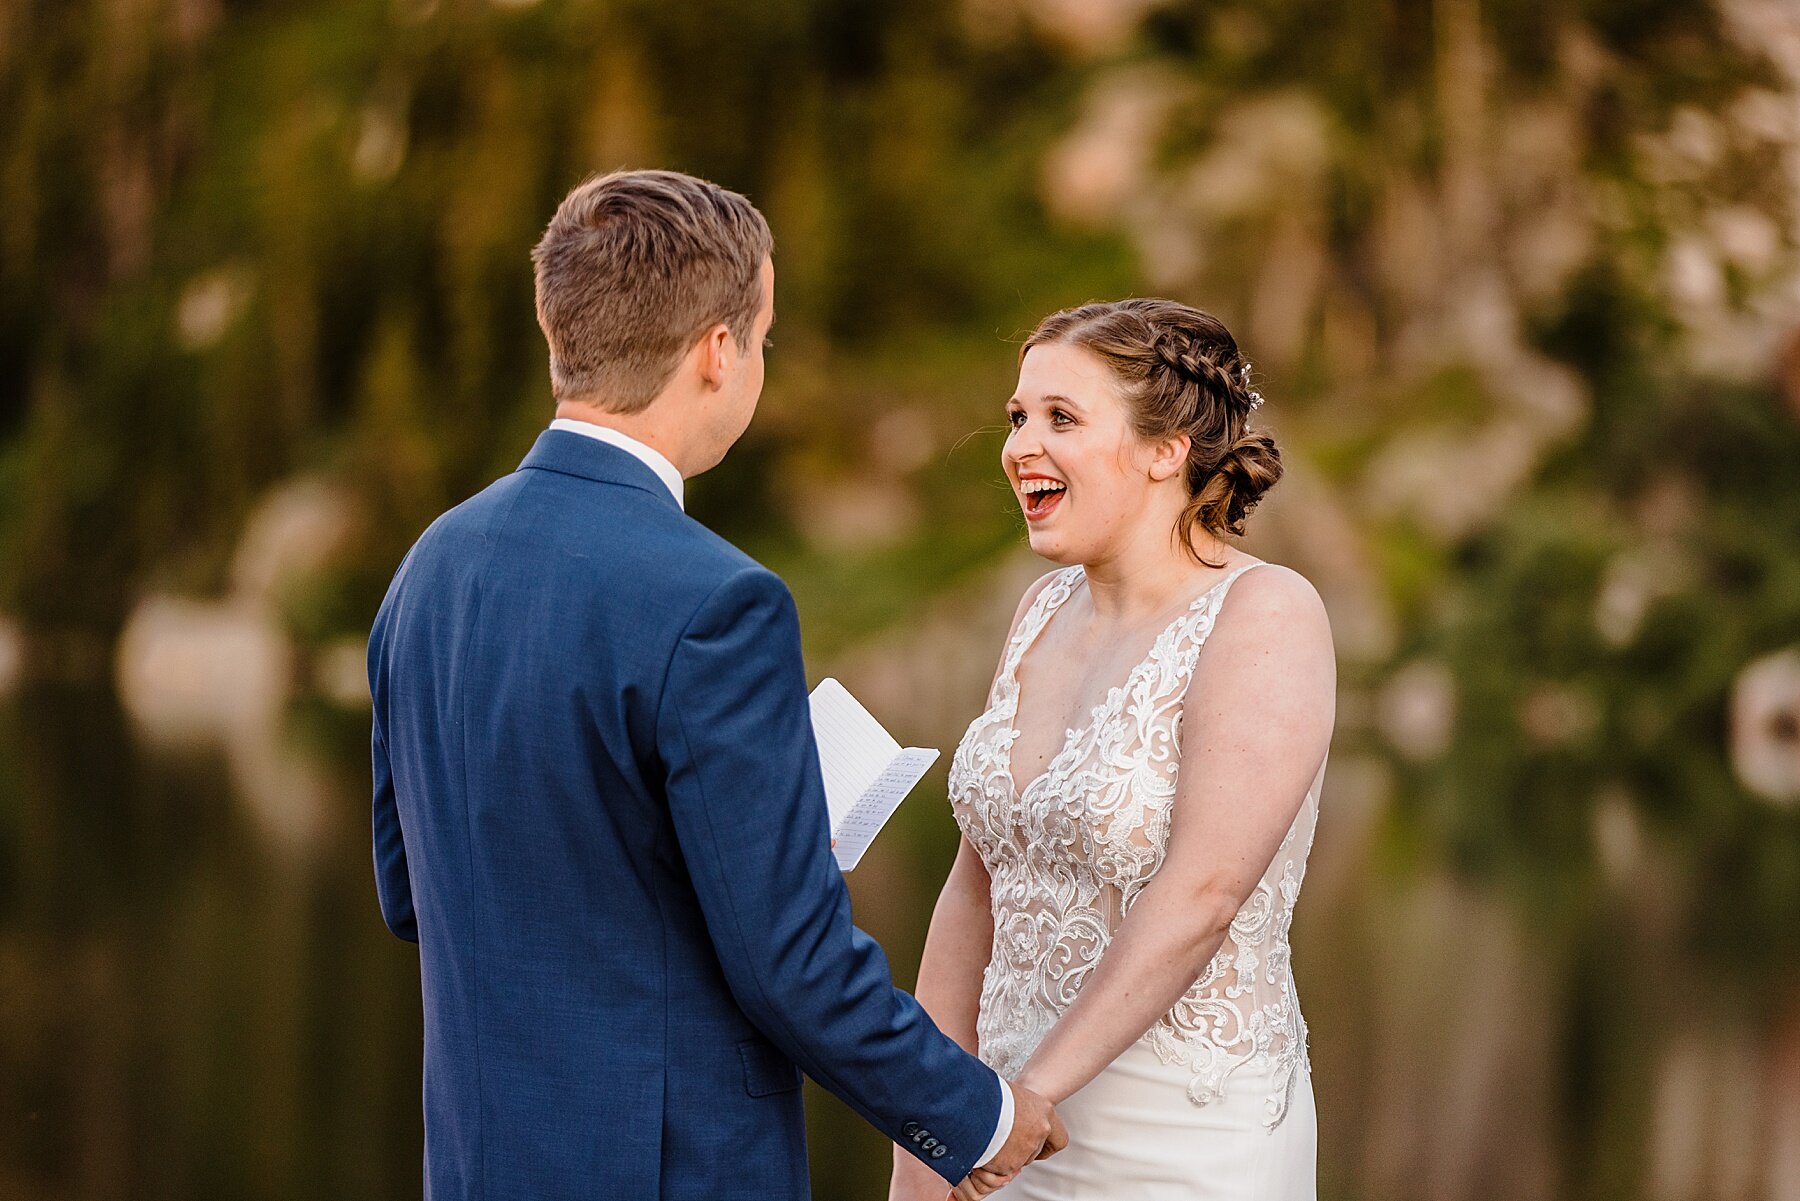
[891, 299, 1336, 1201]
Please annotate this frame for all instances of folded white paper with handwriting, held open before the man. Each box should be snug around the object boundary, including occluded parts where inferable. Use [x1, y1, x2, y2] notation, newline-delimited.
[812, 679, 938, 871]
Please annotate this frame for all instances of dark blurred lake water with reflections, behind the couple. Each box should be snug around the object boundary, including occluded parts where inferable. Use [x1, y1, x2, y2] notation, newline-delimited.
[10, 619, 1800, 1201]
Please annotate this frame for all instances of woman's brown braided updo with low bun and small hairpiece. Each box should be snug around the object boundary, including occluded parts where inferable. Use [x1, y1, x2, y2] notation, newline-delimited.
[1019, 299, 1282, 567]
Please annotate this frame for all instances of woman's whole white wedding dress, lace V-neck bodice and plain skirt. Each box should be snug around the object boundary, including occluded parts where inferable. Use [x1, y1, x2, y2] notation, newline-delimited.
[950, 564, 1325, 1201]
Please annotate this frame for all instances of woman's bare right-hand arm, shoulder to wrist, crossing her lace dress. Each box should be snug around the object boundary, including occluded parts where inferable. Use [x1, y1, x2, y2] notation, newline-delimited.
[1017, 567, 1337, 1104]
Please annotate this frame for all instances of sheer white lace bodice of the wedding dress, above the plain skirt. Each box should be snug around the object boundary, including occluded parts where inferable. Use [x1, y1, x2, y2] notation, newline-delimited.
[950, 564, 1325, 1129]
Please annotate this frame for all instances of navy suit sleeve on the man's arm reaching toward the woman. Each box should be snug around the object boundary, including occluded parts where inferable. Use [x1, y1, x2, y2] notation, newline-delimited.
[657, 567, 1001, 1183]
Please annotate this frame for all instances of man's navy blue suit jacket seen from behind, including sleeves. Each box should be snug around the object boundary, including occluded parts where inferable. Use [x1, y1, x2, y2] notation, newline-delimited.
[369, 430, 1001, 1201]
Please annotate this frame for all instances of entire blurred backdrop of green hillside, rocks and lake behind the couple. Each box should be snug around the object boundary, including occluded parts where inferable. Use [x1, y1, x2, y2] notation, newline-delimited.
[0, 0, 1800, 1201]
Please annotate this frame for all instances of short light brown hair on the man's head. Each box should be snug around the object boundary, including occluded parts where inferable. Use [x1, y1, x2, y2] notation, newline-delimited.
[531, 171, 774, 412]
